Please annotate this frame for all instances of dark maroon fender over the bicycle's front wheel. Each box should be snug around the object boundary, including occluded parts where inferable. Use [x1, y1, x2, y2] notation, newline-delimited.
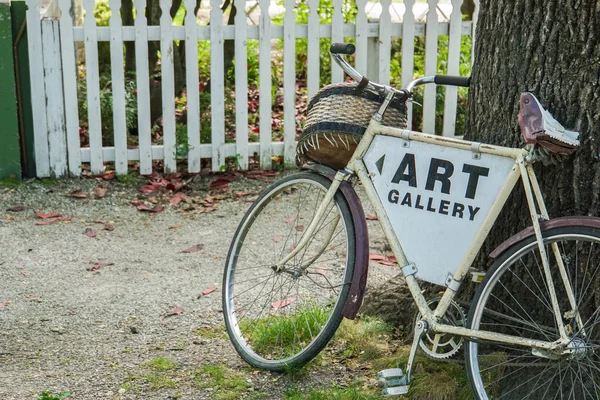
[303, 164, 369, 319]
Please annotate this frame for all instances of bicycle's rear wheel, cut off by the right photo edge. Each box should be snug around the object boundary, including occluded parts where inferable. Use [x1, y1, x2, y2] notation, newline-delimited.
[465, 226, 600, 400]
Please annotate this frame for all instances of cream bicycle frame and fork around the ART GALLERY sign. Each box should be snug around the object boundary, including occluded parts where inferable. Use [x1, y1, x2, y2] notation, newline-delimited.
[277, 114, 585, 351]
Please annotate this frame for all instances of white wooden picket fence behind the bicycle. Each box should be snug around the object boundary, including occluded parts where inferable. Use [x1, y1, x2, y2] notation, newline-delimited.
[27, 0, 475, 177]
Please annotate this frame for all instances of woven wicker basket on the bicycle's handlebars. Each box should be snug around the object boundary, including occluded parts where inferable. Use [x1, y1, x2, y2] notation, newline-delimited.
[296, 83, 407, 169]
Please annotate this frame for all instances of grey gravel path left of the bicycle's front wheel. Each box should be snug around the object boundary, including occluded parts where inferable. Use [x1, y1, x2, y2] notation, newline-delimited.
[0, 177, 397, 400]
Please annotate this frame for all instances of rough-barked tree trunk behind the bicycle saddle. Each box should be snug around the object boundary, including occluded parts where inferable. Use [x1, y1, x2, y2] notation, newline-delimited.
[466, 0, 600, 257]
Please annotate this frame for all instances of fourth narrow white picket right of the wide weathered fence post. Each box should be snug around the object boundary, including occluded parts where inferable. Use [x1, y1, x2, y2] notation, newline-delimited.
[134, 0, 152, 175]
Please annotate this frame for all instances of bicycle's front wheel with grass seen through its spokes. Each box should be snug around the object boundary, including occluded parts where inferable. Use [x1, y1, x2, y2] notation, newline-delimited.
[223, 172, 356, 371]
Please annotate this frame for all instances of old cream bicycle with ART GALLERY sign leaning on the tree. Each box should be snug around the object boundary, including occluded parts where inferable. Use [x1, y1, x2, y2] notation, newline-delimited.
[223, 44, 600, 399]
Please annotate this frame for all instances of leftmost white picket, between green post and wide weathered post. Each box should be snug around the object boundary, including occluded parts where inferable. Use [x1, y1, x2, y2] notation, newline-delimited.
[27, 0, 50, 178]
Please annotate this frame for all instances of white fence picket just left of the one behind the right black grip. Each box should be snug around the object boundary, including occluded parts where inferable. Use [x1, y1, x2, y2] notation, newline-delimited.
[423, 0, 438, 134]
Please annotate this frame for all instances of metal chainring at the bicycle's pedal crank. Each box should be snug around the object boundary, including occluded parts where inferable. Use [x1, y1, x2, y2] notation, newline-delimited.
[416, 297, 466, 359]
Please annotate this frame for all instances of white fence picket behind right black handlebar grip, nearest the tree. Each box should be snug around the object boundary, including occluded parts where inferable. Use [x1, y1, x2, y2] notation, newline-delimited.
[443, 0, 462, 137]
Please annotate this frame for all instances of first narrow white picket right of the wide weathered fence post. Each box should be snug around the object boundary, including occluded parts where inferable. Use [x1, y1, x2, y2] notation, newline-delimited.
[59, 0, 81, 176]
